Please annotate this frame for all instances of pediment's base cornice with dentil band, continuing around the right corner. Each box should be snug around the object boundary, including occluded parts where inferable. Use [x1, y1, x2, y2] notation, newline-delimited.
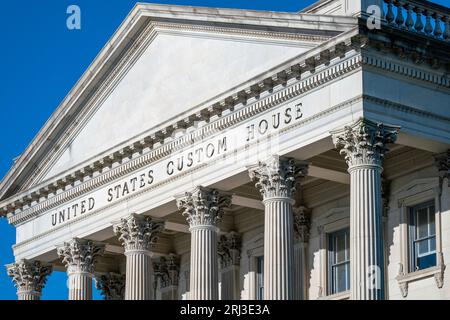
[0, 3, 450, 223]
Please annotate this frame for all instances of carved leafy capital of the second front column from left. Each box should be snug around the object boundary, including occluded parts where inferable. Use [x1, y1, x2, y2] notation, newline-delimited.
[58, 238, 105, 274]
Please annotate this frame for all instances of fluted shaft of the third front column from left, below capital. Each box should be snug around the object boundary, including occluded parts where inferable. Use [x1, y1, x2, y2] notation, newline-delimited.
[125, 250, 153, 300]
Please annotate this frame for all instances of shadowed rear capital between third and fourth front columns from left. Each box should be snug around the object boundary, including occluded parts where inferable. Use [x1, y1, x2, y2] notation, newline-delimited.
[153, 253, 180, 289]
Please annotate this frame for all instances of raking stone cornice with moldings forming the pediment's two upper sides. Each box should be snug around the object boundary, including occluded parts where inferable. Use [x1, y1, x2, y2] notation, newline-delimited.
[0, 4, 356, 199]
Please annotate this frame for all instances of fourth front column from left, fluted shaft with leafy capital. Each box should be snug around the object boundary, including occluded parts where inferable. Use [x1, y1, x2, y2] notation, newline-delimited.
[177, 187, 231, 300]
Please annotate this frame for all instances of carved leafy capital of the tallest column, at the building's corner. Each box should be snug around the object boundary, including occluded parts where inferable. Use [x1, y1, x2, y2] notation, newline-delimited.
[331, 118, 400, 167]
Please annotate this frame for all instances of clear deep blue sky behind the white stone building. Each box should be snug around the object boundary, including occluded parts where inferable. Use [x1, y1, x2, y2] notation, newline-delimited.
[0, 0, 450, 300]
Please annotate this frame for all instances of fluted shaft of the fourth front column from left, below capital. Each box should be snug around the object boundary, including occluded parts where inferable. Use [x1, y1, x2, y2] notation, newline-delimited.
[189, 225, 219, 300]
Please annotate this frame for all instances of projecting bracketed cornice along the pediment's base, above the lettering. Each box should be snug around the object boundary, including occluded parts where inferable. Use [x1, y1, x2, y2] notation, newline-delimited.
[0, 27, 363, 217]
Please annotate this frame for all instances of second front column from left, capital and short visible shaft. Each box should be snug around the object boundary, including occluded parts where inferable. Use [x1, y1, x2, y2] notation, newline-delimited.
[58, 238, 105, 300]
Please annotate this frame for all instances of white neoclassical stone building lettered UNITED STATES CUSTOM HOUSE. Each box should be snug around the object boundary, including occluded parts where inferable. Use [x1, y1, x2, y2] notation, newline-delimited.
[0, 0, 450, 300]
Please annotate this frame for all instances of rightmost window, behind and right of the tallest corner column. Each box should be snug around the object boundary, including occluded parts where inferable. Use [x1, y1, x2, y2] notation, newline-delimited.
[409, 202, 436, 272]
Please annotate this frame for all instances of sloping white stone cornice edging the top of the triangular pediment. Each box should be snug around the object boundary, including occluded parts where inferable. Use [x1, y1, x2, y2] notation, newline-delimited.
[0, 3, 357, 205]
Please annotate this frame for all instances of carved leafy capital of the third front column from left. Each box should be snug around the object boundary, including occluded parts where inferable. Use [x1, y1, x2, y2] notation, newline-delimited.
[114, 214, 164, 252]
